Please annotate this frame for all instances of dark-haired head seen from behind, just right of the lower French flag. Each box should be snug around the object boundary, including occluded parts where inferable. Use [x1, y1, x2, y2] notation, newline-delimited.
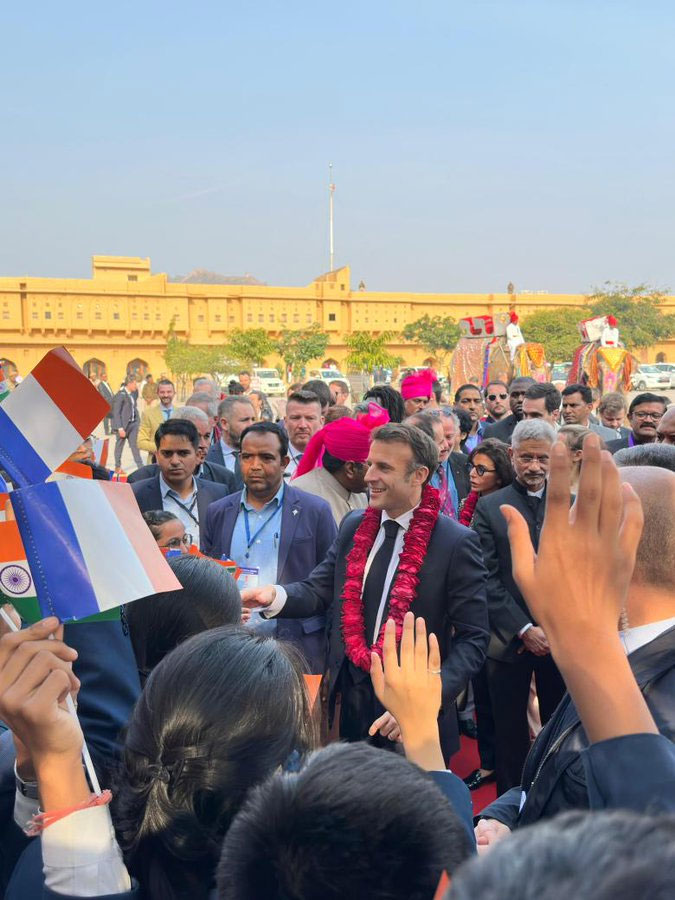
[126, 552, 242, 685]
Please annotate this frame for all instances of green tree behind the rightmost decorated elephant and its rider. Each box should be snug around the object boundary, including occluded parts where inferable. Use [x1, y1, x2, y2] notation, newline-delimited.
[588, 281, 675, 350]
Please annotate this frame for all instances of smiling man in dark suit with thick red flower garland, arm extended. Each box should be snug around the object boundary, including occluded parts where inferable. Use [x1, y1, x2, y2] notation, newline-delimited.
[242, 423, 488, 758]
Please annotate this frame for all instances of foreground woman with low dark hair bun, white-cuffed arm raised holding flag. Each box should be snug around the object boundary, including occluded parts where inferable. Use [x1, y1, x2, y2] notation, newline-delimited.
[6, 624, 315, 900]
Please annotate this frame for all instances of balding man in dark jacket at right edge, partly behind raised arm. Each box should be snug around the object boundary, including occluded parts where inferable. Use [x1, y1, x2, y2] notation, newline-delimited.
[481, 466, 675, 834]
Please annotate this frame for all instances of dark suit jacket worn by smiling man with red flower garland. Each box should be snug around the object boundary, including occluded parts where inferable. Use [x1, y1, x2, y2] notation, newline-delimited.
[281, 510, 489, 708]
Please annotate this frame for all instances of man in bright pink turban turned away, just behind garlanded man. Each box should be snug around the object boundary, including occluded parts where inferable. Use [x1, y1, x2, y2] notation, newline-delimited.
[293, 412, 388, 526]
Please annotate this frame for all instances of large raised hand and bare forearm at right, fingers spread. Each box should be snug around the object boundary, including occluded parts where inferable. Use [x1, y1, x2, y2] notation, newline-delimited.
[502, 434, 657, 743]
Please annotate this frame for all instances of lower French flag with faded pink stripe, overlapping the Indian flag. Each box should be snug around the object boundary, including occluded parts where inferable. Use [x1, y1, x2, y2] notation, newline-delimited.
[12, 478, 181, 622]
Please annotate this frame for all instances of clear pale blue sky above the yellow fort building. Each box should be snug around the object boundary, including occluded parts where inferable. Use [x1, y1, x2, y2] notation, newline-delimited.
[0, 0, 675, 292]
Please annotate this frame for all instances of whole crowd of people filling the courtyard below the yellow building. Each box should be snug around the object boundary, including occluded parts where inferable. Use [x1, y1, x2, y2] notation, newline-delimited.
[0, 371, 675, 900]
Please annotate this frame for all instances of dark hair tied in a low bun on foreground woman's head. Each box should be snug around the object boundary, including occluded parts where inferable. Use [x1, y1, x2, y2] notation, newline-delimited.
[113, 626, 313, 900]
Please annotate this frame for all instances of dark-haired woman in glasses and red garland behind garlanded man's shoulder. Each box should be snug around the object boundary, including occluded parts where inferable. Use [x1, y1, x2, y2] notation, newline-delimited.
[459, 438, 513, 791]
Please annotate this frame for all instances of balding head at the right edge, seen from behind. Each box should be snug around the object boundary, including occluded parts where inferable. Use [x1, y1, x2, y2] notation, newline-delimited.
[619, 466, 675, 596]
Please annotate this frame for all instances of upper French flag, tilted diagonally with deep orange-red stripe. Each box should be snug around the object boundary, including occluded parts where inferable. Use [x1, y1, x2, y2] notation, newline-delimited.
[0, 347, 110, 487]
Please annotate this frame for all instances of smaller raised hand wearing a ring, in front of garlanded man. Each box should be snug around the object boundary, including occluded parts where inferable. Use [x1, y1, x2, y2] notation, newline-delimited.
[370, 612, 445, 770]
